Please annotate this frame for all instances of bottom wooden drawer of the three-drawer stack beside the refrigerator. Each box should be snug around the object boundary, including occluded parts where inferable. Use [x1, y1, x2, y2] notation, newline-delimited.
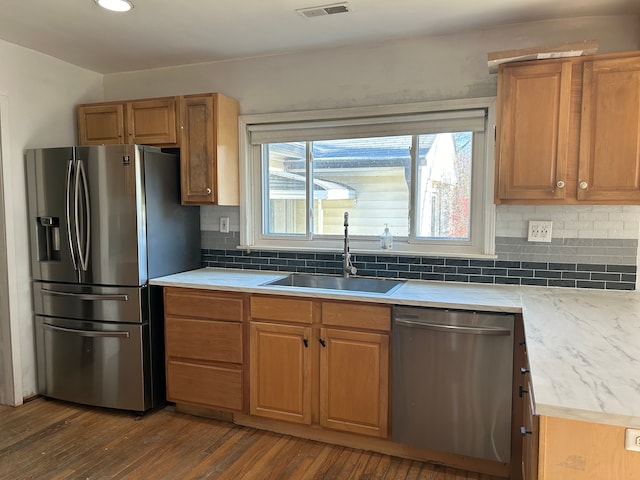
[167, 361, 243, 411]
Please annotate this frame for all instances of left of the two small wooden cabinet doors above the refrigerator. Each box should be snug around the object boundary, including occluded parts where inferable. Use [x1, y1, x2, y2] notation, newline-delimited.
[77, 104, 126, 145]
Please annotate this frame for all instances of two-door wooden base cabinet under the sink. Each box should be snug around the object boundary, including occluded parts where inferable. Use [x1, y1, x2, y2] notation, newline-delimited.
[249, 296, 391, 438]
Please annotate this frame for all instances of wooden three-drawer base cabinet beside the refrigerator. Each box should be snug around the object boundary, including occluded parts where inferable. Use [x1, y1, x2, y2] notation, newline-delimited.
[164, 287, 246, 412]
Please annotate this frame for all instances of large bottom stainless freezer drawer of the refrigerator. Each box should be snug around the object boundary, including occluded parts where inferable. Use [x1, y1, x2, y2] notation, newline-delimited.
[36, 315, 151, 412]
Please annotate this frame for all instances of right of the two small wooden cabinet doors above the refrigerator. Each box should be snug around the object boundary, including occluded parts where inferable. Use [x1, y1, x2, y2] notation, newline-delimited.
[126, 97, 177, 145]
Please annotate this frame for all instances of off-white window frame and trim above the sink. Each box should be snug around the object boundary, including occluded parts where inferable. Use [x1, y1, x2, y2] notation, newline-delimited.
[238, 97, 496, 258]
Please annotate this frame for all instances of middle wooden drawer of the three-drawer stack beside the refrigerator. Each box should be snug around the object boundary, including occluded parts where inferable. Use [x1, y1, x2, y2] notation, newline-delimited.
[165, 317, 242, 364]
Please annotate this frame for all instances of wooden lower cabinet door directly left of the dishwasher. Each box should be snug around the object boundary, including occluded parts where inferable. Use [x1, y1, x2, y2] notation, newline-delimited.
[320, 328, 389, 438]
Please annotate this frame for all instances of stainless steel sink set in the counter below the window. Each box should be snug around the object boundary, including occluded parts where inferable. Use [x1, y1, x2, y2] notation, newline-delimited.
[263, 273, 405, 294]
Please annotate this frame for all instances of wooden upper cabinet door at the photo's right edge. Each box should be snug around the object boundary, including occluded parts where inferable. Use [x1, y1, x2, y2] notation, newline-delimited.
[577, 57, 640, 203]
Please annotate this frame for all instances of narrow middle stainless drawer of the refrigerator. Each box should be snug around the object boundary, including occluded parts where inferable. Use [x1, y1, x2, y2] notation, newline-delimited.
[33, 282, 149, 323]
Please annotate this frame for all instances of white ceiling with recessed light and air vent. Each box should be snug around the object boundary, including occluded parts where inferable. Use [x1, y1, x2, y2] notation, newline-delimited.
[0, 0, 640, 73]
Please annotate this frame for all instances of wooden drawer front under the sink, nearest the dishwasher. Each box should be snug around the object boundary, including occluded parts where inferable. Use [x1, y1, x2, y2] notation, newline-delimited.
[322, 302, 391, 332]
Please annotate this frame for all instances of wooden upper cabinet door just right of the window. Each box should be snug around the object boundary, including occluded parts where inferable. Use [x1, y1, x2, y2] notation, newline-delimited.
[496, 62, 572, 203]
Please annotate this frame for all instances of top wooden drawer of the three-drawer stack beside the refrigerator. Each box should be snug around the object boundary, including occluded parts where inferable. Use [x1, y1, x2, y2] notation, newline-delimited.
[164, 288, 243, 322]
